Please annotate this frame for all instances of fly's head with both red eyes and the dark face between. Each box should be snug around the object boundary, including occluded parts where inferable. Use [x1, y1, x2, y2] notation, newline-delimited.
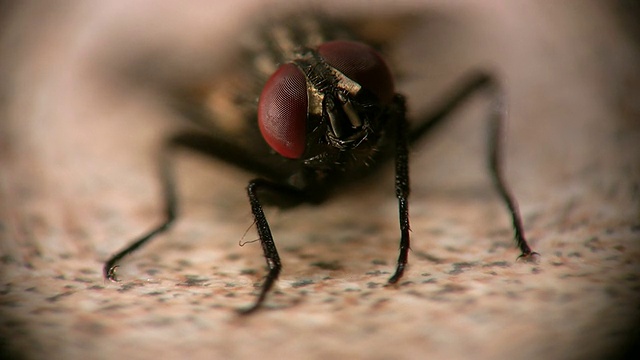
[258, 40, 394, 168]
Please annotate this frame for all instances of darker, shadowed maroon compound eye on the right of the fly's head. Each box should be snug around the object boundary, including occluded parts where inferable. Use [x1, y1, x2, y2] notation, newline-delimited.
[318, 40, 395, 103]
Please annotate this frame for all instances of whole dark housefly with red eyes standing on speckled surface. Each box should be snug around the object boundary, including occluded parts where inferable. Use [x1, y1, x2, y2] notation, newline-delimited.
[104, 16, 536, 314]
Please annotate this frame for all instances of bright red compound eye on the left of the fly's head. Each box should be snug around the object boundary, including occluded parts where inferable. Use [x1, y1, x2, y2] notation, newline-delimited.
[258, 64, 309, 159]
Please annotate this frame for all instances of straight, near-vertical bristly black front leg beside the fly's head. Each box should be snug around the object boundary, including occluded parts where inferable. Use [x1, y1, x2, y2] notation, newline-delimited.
[389, 95, 411, 284]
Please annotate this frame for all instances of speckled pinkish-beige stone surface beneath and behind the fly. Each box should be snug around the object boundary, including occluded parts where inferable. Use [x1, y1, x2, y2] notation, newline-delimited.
[0, 1, 640, 359]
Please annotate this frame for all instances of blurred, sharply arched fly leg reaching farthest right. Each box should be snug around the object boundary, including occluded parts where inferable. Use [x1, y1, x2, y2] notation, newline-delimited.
[408, 73, 538, 259]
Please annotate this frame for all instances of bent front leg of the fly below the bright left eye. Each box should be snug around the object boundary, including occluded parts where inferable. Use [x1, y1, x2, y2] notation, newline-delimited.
[238, 179, 303, 314]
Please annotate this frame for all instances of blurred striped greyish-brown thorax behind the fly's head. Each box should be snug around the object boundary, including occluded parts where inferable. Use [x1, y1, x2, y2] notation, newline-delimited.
[190, 16, 353, 134]
